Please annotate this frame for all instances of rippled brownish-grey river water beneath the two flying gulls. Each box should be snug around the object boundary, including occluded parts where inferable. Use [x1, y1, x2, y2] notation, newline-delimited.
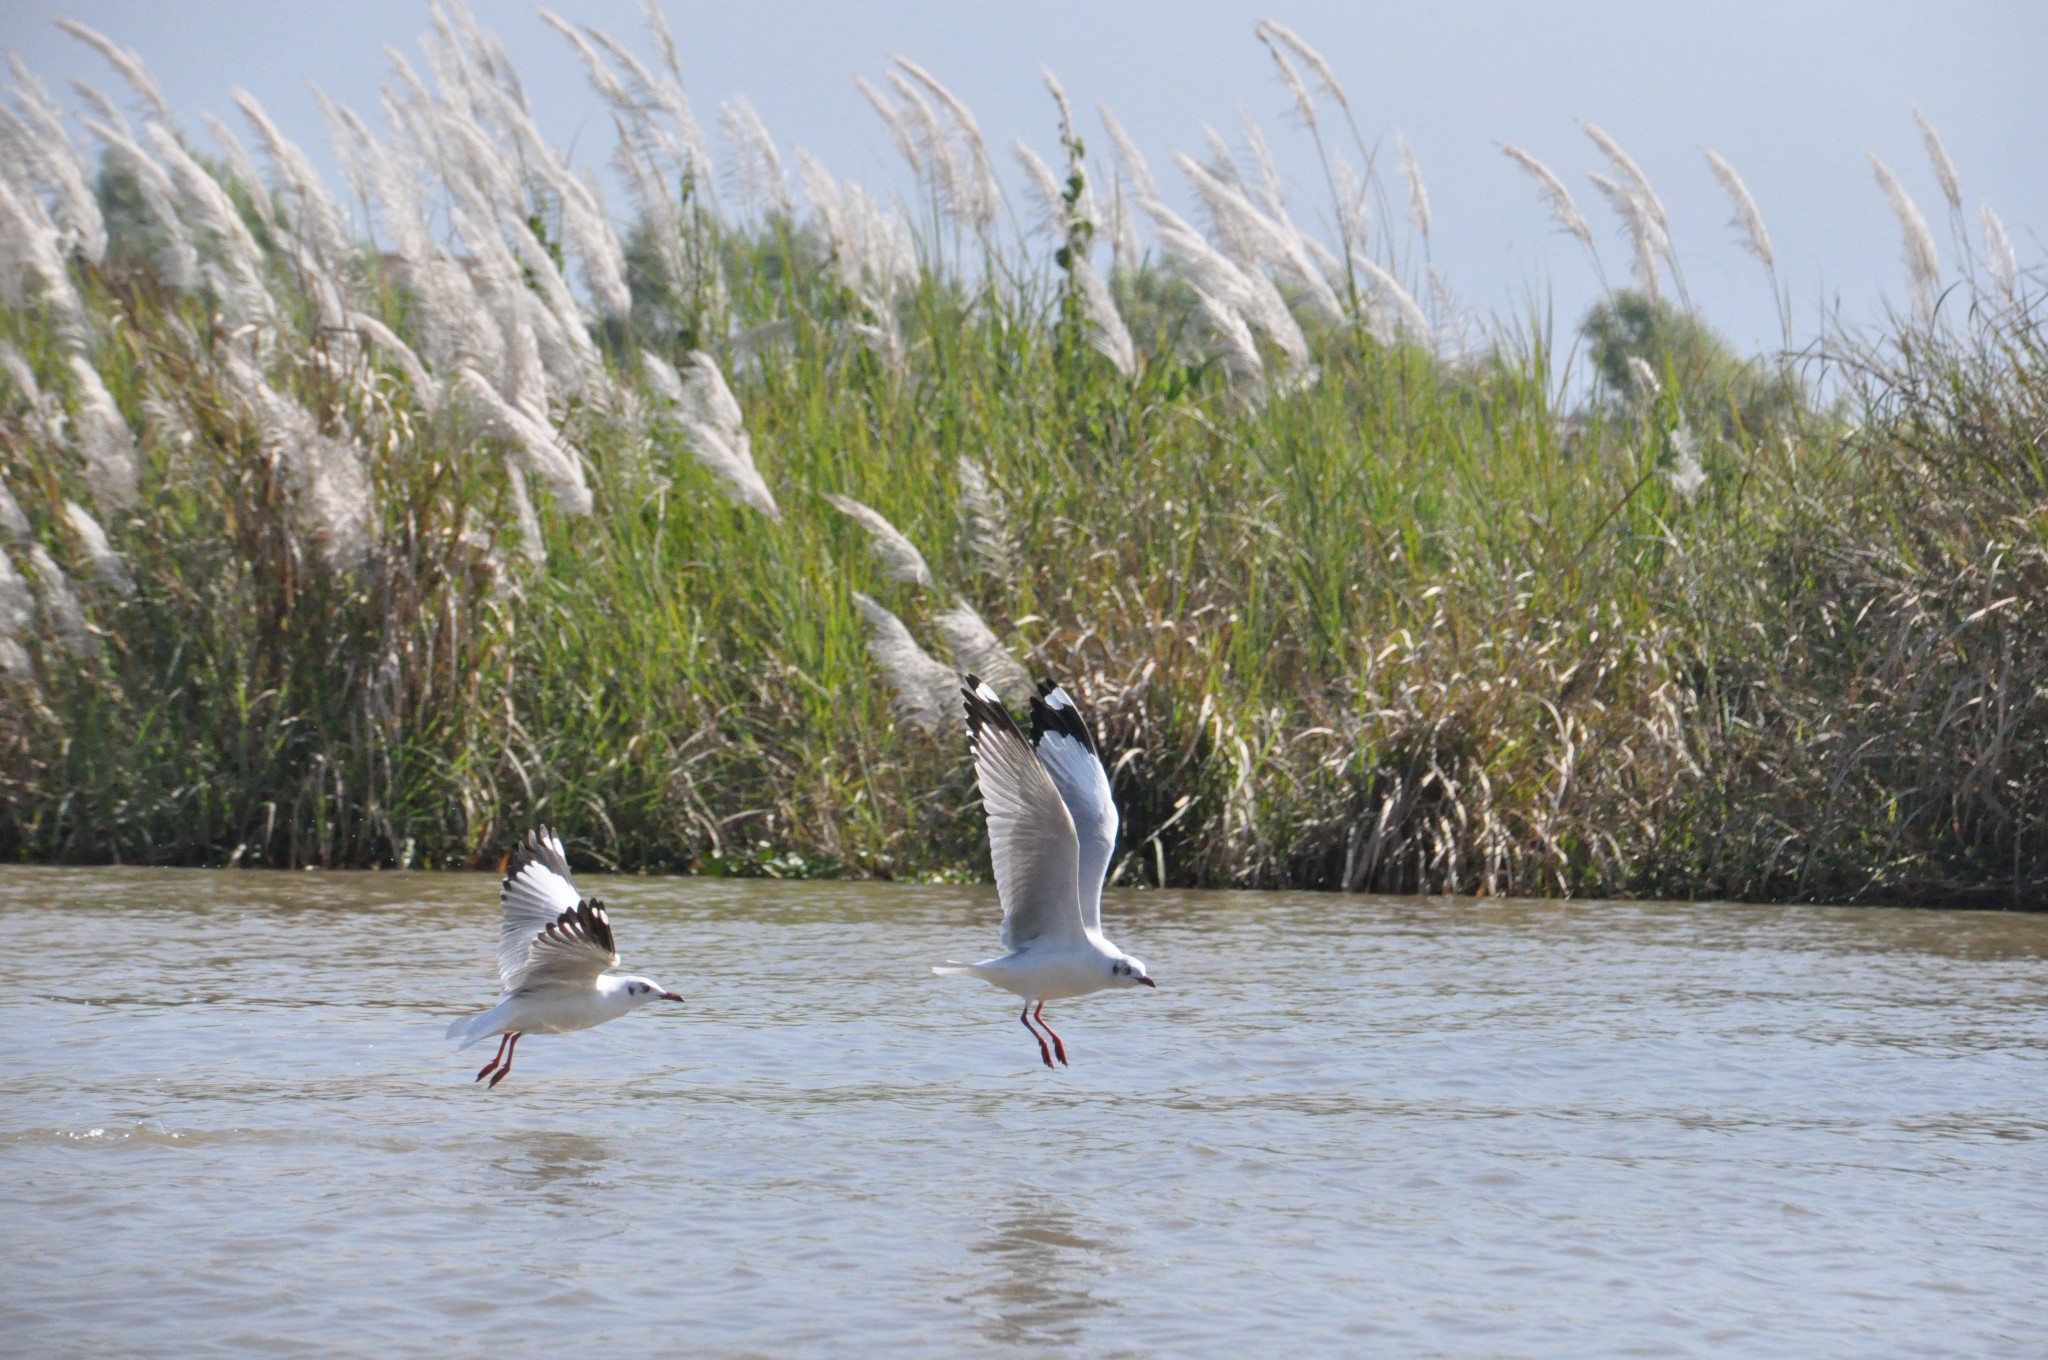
[0, 868, 2048, 1358]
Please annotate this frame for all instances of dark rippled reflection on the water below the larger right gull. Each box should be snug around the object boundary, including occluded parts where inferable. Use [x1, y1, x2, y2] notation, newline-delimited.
[961, 1192, 1122, 1346]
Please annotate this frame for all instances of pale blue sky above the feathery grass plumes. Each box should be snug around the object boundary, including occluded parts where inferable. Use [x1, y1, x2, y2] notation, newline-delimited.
[0, 0, 2048, 356]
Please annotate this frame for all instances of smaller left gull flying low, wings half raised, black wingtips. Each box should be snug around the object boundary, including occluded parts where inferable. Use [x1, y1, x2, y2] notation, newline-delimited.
[449, 827, 682, 1086]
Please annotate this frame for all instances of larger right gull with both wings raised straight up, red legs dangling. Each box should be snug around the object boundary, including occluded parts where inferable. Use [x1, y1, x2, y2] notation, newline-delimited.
[932, 676, 1157, 1067]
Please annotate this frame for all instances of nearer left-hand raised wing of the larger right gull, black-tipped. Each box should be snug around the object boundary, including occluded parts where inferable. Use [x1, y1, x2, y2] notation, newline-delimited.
[961, 676, 1083, 950]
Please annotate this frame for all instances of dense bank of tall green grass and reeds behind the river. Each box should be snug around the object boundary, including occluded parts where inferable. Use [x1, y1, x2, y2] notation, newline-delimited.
[0, 13, 2048, 905]
